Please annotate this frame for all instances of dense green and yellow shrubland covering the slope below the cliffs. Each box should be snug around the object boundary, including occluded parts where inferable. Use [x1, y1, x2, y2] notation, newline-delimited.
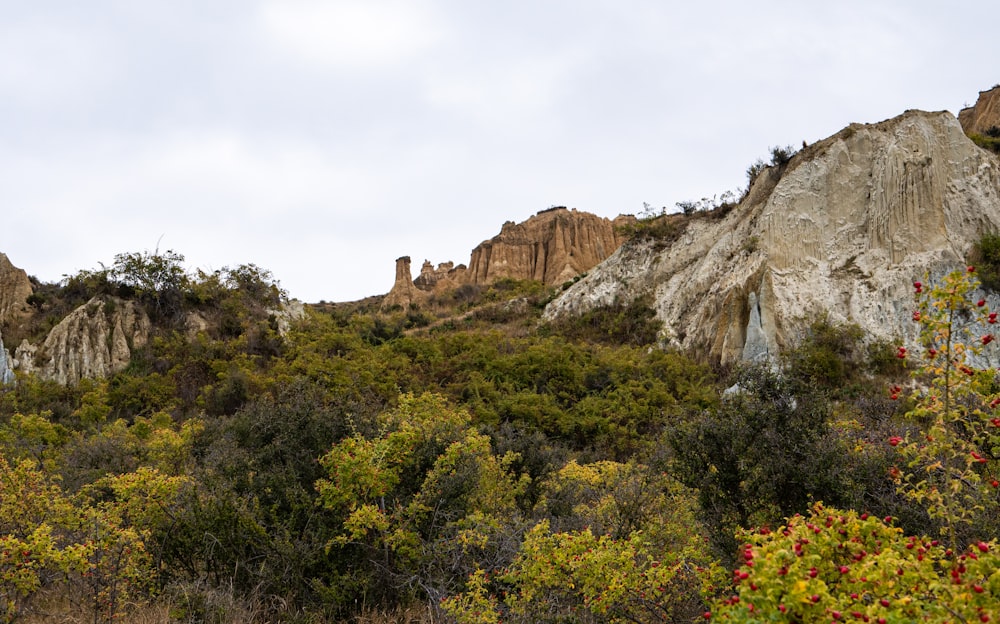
[0, 252, 1000, 622]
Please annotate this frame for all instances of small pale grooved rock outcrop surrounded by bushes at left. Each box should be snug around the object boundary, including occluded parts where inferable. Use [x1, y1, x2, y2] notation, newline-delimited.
[13, 297, 151, 384]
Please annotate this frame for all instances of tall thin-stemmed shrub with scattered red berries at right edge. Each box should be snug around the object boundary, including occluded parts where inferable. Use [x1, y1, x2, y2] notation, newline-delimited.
[890, 266, 1000, 548]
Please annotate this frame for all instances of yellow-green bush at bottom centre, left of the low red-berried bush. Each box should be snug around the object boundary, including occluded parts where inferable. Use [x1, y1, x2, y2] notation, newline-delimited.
[443, 462, 722, 624]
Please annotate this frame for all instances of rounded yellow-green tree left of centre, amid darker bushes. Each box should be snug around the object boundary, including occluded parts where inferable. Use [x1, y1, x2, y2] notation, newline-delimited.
[317, 395, 526, 596]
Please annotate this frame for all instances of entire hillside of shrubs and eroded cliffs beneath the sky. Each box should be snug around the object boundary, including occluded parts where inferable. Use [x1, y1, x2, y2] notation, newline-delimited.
[0, 92, 1000, 624]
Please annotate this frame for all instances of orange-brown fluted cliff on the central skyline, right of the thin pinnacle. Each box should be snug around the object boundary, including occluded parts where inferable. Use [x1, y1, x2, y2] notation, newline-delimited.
[465, 208, 624, 286]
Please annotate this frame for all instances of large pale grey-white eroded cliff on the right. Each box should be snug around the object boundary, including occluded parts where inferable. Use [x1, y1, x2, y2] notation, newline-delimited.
[545, 111, 1000, 362]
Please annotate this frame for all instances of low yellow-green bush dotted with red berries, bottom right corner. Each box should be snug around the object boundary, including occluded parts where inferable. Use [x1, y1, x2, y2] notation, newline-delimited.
[705, 503, 1000, 624]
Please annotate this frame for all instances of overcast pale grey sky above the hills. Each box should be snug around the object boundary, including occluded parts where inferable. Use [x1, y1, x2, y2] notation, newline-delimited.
[0, 0, 1000, 303]
